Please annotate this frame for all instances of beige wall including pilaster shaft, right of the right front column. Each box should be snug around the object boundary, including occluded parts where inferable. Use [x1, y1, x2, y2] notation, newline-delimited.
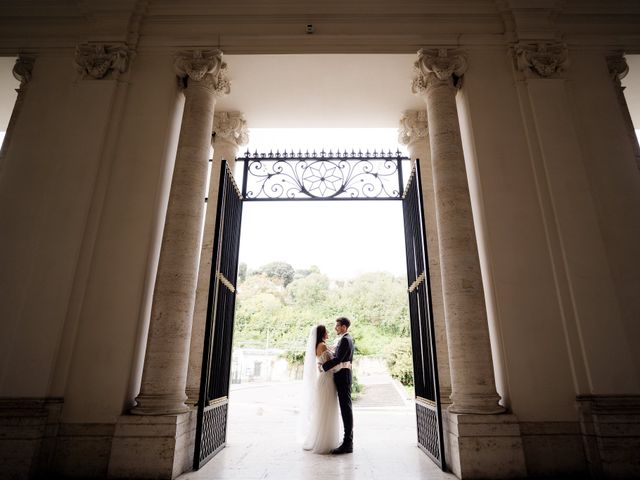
[458, 48, 640, 421]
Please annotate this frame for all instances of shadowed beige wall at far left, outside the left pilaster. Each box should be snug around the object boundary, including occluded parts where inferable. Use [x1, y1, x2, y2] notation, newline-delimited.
[0, 53, 114, 397]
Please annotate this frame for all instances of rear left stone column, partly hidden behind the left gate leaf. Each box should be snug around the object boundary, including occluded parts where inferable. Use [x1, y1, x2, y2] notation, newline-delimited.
[187, 112, 249, 404]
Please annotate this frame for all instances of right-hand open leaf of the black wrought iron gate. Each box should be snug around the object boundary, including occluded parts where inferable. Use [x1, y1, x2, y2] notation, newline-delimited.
[402, 160, 445, 469]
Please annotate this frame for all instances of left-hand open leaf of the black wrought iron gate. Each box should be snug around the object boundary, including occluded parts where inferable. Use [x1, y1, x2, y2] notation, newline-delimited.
[193, 161, 242, 470]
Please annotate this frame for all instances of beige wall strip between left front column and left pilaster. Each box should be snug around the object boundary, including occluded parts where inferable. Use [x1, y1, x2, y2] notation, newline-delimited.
[63, 52, 183, 423]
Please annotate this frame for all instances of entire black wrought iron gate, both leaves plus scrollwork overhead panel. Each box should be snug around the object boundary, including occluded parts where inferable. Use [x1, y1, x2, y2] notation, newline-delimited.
[194, 152, 444, 470]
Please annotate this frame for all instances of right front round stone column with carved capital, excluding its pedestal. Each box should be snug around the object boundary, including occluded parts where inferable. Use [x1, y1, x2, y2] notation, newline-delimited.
[413, 49, 504, 414]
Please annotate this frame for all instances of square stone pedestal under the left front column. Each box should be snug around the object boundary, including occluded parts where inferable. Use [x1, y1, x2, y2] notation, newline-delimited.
[108, 410, 196, 479]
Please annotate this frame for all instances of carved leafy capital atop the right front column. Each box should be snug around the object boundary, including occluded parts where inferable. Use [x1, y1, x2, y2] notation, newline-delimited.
[411, 48, 467, 95]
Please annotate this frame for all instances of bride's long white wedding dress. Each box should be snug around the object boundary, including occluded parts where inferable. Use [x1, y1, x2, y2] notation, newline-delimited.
[302, 338, 340, 454]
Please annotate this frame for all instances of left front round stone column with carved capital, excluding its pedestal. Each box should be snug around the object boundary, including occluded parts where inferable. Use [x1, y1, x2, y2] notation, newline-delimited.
[131, 50, 229, 415]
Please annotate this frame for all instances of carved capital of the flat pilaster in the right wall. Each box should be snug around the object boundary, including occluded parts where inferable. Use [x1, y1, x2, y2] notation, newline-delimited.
[514, 42, 569, 78]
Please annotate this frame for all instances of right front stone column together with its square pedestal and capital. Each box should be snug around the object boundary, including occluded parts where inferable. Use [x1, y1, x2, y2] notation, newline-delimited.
[413, 49, 526, 478]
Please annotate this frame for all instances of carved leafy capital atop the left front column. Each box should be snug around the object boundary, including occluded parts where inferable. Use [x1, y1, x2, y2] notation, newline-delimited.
[174, 50, 231, 97]
